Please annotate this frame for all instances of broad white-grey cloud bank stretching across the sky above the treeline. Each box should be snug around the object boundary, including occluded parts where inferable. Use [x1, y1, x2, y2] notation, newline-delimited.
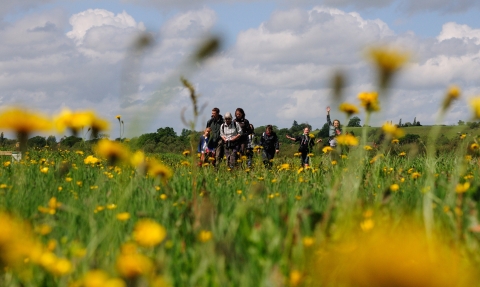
[0, 4, 480, 140]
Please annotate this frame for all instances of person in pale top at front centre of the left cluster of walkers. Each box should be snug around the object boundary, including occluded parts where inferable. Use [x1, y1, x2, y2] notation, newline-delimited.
[220, 112, 242, 169]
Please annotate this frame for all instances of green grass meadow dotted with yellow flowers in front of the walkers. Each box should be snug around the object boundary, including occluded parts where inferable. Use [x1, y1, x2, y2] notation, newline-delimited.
[0, 132, 480, 286]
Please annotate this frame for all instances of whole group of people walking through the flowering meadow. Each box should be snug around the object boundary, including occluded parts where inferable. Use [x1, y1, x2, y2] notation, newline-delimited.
[198, 107, 341, 169]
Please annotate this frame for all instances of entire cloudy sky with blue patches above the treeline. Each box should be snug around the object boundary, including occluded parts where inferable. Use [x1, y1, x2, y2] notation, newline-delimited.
[0, 0, 480, 138]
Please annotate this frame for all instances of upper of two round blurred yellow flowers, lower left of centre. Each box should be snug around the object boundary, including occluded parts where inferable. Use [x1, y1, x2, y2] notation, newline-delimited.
[133, 219, 167, 247]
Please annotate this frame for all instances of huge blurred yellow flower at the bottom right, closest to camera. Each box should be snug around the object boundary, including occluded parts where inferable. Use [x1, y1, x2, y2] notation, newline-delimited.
[308, 222, 476, 287]
